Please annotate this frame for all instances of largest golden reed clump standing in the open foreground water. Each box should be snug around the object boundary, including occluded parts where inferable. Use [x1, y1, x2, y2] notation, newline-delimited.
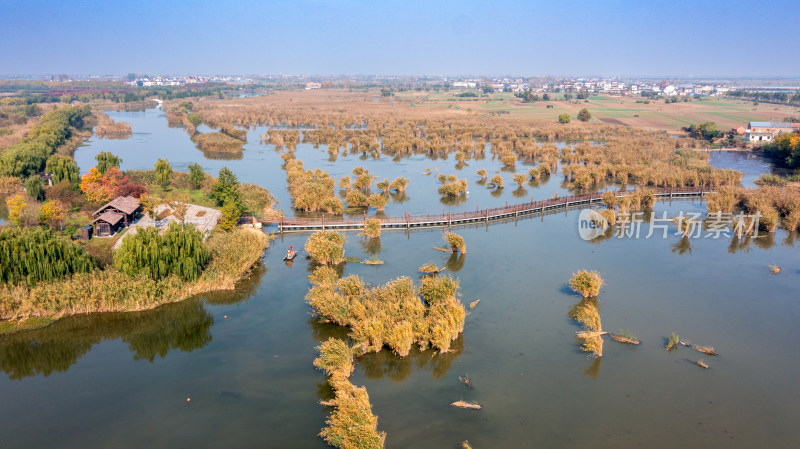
[306, 267, 466, 357]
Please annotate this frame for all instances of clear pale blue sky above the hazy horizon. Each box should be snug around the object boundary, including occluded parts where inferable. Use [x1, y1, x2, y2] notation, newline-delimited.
[0, 0, 800, 77]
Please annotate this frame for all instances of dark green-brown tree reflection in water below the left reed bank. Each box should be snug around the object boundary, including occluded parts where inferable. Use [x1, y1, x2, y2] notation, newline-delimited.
[0, 299, 214, 379]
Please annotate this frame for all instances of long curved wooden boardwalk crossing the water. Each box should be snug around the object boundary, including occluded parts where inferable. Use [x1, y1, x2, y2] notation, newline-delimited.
[259, 188, 709, 232]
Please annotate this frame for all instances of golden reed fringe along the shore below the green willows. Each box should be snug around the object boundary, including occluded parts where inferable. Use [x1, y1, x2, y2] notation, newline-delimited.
[0, 228, 269, 333]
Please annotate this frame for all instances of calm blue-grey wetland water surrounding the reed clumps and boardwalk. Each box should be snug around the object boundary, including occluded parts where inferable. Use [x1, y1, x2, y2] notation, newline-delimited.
[0, 110, 800, 448]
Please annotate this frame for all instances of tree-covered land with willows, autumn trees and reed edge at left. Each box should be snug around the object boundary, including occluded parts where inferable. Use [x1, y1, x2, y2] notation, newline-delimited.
[0, 106, 273, 333]
